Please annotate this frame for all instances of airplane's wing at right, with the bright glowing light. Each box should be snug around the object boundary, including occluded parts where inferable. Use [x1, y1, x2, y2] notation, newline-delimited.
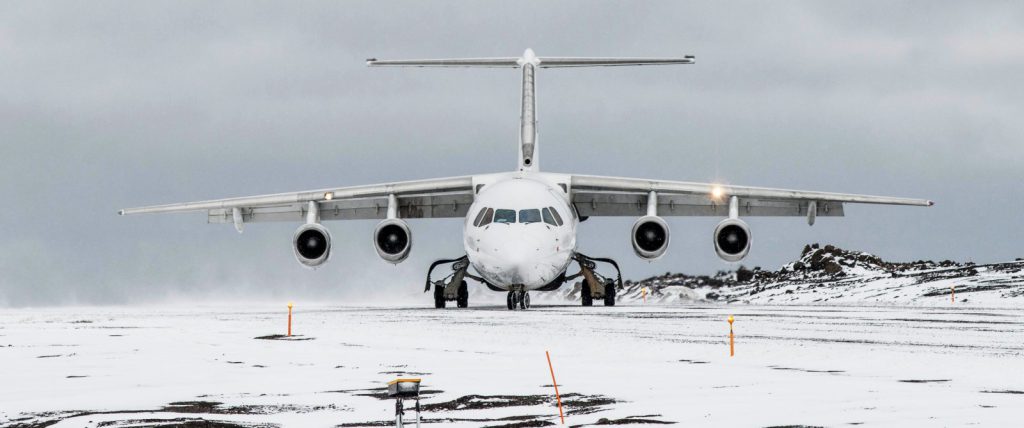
[571, 175, 934, 218]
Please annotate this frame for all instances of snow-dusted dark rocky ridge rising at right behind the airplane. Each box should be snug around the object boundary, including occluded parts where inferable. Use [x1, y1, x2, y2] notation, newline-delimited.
[606, 244, 1024, 308]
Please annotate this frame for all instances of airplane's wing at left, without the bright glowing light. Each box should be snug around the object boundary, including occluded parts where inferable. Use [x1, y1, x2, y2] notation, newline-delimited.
[118, 176, 473, 230]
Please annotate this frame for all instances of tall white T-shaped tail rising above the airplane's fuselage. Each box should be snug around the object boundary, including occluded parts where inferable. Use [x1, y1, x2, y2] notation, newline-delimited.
[367, 49, 694, 171]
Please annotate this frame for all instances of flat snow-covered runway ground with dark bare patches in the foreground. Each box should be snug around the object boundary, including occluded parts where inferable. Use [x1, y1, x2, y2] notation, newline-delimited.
[0, 302, 1024, 427]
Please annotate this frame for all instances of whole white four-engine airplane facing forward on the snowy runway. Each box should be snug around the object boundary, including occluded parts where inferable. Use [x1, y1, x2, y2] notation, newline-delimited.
[120, 49, 933, 309]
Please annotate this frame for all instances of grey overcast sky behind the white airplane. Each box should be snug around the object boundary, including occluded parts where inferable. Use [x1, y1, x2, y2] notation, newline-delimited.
[0, 1, 1024, 306]
